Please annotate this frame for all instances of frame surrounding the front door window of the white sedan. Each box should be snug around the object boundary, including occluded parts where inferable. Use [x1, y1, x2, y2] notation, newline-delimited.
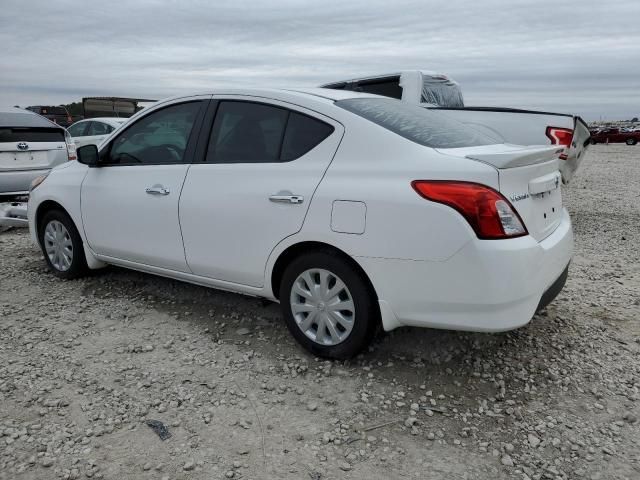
[94, 95, 211, 168]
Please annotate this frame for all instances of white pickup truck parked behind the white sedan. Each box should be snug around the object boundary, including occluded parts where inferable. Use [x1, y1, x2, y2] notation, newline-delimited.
[322, 70, 590, 183]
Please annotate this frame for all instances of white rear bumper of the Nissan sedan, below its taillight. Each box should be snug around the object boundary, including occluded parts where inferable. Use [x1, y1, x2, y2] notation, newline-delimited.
[356, 210, 573, 332]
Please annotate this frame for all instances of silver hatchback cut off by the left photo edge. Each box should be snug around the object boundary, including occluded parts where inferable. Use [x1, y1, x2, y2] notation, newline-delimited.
[0, 107, 75, 197]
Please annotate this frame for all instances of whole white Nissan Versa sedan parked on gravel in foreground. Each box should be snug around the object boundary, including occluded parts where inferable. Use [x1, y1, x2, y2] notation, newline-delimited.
[28, 89, 573, 358]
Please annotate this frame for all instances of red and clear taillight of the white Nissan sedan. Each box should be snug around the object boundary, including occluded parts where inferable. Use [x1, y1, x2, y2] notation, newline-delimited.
[411, 180, 527, 240]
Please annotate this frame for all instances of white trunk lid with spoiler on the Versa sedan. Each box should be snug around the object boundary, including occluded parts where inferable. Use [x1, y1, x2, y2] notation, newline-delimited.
[438, 145, 564, 241]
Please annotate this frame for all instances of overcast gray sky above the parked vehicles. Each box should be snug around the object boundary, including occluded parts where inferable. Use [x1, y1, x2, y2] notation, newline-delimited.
[0, 0, 640, 120]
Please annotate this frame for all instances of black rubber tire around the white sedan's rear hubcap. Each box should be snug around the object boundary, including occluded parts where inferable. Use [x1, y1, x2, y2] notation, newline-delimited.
[279, 251, 380, 360]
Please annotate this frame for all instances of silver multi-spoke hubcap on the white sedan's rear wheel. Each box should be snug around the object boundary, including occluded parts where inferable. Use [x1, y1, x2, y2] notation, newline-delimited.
[290, 268, 356, 346]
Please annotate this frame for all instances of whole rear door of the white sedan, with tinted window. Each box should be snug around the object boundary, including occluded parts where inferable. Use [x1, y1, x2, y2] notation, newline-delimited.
[180, 96, 343, 287]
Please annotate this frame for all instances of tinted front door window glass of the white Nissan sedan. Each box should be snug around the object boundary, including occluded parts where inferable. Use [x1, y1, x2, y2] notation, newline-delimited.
[107, 101, 201, 165]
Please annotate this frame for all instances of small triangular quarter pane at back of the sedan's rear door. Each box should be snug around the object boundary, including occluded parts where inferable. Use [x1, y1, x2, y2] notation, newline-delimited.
[281, 112, 334, 162]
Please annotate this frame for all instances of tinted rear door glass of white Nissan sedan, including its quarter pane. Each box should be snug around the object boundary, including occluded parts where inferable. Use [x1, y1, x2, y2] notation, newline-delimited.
[206, 101, 334, 163]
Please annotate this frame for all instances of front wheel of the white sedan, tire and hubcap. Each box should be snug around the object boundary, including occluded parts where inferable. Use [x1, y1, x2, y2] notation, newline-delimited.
[38, 210, 88, 279]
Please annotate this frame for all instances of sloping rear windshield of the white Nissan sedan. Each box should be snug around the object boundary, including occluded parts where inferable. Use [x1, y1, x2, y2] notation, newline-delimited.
[335, 98, 502, 148]
